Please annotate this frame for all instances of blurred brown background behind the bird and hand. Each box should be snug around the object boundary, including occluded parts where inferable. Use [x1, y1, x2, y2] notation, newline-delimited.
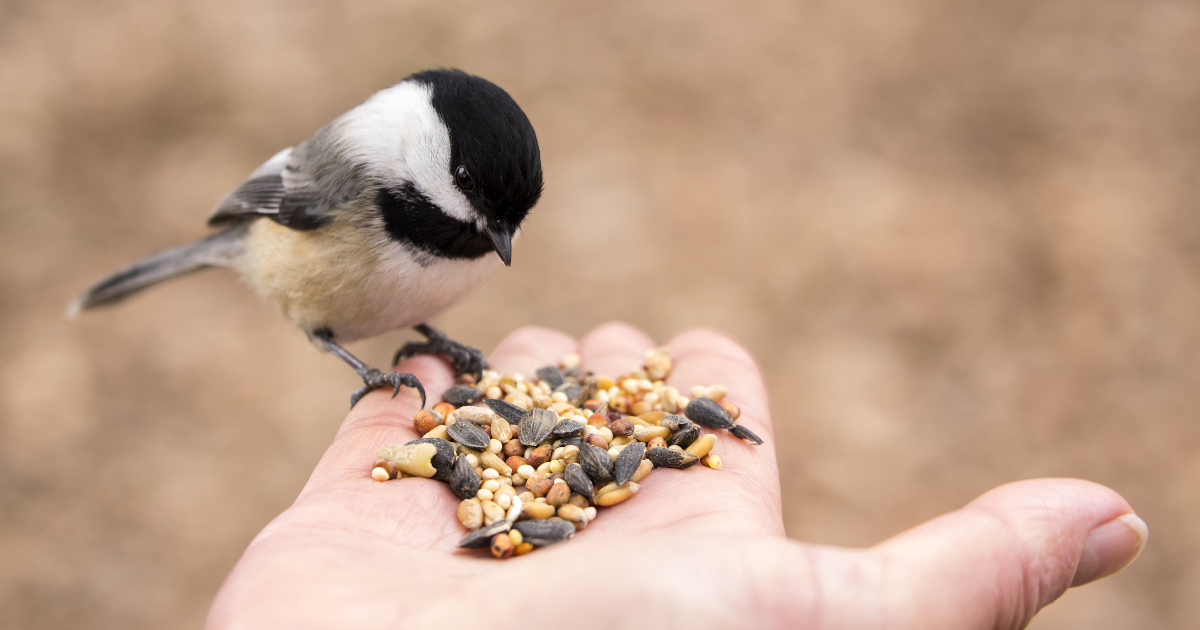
[0, 0, 1200, 630]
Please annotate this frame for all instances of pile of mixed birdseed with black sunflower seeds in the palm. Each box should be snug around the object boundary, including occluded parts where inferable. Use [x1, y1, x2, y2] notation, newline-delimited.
[371, 348, 762, 558]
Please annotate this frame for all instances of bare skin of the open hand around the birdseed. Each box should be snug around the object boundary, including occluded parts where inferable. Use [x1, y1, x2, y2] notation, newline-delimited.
[208, 324, 1147, 630]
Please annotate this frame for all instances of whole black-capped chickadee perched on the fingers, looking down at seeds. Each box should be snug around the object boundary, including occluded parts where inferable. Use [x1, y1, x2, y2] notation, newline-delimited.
[68, 70, 542, 407]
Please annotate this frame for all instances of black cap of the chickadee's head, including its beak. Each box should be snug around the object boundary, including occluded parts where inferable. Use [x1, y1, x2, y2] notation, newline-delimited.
[406, 70, 542, 265]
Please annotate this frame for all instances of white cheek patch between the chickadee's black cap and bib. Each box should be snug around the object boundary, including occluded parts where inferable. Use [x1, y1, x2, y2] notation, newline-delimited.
[338, 82, 482, 227]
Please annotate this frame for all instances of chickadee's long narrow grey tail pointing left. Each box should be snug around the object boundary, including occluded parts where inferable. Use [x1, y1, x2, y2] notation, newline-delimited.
[67, 223, 247, 317]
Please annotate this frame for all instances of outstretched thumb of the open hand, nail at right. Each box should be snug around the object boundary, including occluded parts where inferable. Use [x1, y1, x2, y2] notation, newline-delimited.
[868, 479, 1148, 628]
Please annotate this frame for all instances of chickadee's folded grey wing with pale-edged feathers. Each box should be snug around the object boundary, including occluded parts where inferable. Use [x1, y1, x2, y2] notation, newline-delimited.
[209, 145, 337, 230]
